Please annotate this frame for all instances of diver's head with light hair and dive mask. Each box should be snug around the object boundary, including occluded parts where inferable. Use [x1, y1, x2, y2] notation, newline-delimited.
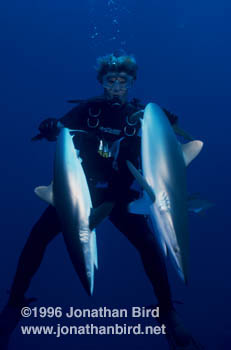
[96, 52, 138, 106]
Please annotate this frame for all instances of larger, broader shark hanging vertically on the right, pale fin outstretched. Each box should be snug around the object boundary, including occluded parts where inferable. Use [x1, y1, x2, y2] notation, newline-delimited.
[127, 103, 203, 282]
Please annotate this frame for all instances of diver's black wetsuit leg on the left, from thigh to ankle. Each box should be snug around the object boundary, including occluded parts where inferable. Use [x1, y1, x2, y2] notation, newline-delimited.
[8, 206, 61, 305]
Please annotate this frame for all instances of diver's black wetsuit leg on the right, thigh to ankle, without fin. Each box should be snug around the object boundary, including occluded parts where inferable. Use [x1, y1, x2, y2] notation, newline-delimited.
[110, 204, 172, 309]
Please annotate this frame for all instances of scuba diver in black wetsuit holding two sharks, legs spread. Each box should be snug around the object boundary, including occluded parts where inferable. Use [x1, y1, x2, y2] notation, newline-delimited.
[0, 53, 200, 350]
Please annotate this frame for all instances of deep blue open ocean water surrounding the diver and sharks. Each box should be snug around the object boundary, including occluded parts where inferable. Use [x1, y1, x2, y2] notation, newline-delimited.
[0, 0, 231, 350]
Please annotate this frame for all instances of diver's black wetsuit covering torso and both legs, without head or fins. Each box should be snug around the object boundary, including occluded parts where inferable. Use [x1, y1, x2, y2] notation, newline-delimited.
[9, 97, 177, 308]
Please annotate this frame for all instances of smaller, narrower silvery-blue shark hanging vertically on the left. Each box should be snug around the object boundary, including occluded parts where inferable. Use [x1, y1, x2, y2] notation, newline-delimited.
[35, 128, 97, 295]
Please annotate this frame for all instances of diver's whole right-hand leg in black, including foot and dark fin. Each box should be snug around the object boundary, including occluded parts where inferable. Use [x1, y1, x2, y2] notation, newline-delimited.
[110, 204, 202, 350]
